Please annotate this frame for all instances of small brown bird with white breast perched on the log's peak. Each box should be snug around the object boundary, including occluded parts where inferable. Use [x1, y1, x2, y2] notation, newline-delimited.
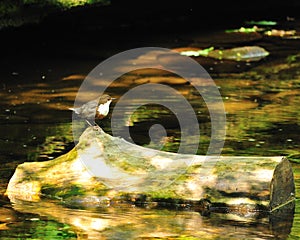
[69, 94, 115, 126]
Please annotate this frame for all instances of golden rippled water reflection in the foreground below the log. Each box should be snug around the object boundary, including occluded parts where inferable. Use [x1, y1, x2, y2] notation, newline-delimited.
[0, 201, 292, 239]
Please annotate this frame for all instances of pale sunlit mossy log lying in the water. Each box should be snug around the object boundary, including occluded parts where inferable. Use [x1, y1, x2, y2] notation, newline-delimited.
[6, 127, 295, 211]
